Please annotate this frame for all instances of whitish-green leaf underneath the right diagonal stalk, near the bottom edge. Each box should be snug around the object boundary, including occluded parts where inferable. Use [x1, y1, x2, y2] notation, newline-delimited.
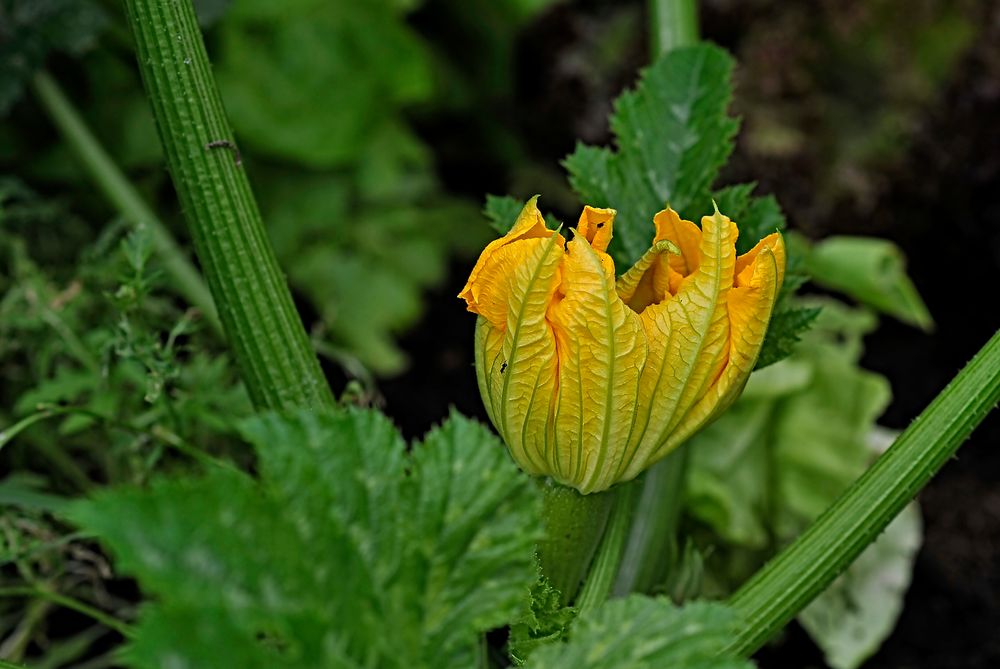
[798, 503, 921, 669]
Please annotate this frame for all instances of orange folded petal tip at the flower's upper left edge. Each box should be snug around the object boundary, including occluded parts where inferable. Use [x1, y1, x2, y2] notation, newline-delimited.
[458, 195, 562, 328]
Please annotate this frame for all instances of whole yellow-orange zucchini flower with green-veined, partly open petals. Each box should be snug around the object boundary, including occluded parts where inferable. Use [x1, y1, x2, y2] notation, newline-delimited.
[459, 197, 785, 494]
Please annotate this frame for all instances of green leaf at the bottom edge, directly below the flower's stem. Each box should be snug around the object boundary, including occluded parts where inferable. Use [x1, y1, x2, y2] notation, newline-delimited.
[529, 595, 753, 669]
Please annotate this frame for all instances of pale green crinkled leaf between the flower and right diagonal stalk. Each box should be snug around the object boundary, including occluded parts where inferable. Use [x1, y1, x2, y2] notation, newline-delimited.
[687, 301, 890, 560]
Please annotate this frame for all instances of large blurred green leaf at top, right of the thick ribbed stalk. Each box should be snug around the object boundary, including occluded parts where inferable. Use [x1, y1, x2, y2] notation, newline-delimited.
[215, 0, 433, 168]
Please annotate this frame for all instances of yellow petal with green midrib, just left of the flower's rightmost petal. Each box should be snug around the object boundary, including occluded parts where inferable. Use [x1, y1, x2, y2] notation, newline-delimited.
[617, 207, 736, 480]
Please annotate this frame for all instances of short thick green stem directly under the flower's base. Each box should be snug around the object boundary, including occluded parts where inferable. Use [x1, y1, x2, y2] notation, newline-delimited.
[538, 480, 614, 605]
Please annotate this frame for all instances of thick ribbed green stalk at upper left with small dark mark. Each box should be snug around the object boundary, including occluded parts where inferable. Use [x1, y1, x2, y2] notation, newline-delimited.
[125, 0, 334, 409]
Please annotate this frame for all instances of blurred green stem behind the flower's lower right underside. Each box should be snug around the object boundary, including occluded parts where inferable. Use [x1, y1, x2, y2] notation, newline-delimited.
[614, 445, 688, 597]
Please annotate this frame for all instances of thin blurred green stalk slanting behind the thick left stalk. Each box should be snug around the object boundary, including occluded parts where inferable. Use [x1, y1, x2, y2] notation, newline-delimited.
[32, 72, 222, 334]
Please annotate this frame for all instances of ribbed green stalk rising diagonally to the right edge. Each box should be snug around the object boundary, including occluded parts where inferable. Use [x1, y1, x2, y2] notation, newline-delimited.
[727, 331, 1000, 656]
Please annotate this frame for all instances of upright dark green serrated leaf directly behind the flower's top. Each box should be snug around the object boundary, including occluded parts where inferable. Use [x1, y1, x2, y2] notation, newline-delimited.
[565, 44, 738, 267]
